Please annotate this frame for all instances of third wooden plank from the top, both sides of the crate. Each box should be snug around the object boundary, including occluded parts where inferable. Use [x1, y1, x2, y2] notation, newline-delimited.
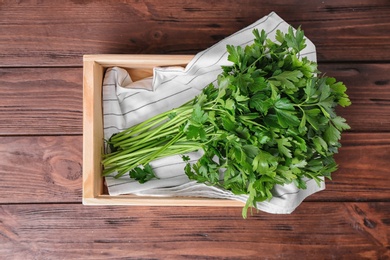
[0, 133, 390, 203]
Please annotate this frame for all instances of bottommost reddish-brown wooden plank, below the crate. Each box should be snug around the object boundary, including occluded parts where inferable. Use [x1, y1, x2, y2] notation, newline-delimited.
[0, 202, 390, 259]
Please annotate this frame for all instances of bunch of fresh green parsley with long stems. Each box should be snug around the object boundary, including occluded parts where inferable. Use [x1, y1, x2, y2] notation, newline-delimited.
[102, 28, 351, 217]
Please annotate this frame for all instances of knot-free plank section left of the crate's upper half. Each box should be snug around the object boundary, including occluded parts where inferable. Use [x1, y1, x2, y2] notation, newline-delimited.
[0, 68, 83, 135]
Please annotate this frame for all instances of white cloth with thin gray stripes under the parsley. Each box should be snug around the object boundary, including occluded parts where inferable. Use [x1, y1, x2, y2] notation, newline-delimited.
[103, 12, 325, 214]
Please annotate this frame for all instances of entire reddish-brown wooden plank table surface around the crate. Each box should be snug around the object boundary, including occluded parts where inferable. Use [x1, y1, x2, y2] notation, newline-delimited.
[0, 0, 390, 259]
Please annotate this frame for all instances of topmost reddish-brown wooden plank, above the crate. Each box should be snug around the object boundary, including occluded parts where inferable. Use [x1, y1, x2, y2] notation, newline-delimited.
[0, 0, 390, 67]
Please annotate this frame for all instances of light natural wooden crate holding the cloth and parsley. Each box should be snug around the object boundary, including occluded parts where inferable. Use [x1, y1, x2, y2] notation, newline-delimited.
[83, 55, 243, 207]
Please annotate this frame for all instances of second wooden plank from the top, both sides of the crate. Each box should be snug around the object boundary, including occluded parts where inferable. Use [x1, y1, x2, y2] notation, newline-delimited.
[0, 63, 390, 135]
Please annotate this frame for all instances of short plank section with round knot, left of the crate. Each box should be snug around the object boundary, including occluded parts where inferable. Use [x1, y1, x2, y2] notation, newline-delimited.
[0, 136, 83, 203]
